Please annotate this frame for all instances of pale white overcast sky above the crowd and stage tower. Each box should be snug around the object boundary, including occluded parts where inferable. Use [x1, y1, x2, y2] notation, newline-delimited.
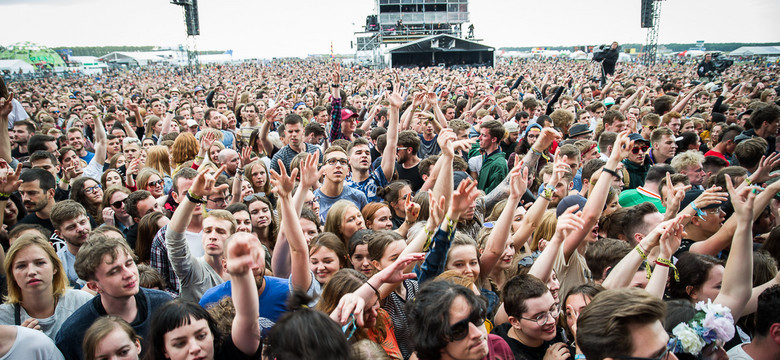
[0, 0, 780, 58]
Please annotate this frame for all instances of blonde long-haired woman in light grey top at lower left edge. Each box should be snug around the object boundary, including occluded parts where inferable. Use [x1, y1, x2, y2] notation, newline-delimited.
[0, 233, 92, 339]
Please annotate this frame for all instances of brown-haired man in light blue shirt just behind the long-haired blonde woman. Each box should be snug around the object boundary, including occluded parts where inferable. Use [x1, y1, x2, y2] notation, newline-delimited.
[51, 200, 92, 289]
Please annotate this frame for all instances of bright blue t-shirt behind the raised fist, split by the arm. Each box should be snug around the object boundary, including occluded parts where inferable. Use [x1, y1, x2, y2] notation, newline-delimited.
[198, 276, 290, 334]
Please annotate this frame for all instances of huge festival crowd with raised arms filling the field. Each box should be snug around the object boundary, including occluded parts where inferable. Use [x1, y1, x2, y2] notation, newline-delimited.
[0, 54, 780, 360]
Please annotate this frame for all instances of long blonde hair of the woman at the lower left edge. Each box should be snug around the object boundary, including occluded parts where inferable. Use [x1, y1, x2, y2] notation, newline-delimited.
[4, 233, 70, 304]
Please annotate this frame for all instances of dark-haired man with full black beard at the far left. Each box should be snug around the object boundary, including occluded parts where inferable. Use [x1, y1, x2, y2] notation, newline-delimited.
[17, 168, 55, 232]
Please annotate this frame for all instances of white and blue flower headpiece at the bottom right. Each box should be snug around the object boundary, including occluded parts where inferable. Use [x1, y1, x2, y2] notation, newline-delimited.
[672, 300, 734, 355]
